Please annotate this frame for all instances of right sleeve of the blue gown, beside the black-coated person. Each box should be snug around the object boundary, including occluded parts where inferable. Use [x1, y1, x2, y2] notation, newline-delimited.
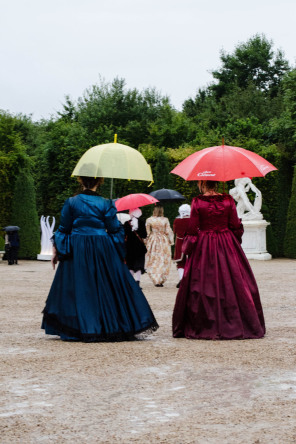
[104, 199, 126, 259]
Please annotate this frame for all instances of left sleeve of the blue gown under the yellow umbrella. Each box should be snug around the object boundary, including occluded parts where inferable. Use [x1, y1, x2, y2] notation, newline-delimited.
[52, 199, 73, 260]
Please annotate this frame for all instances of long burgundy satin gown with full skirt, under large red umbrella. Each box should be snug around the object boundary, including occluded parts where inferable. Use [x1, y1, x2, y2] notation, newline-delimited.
[173, 194, 265, 339]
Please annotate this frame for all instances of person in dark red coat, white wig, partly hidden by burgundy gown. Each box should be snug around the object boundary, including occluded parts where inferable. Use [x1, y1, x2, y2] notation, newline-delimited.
[173, 204, 190, 288]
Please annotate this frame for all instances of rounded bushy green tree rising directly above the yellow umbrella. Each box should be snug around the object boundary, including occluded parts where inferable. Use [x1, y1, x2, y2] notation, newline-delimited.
[77, 78, 168, 148]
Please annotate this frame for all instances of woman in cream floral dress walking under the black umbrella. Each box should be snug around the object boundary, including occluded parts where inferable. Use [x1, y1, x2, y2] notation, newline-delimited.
[145, 205, 174, 287]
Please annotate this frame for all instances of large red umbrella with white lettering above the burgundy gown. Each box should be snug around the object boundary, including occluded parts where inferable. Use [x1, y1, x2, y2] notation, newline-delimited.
[171, 145, 277, 182]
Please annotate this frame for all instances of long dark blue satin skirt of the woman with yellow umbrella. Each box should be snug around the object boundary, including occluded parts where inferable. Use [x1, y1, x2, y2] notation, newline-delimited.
[42, 230, 158, 342]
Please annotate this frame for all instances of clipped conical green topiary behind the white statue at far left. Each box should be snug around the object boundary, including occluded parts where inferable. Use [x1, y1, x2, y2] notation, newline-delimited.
[11, 170, 40, 259]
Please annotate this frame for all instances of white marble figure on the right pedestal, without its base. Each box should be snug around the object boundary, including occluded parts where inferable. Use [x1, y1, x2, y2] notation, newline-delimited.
[229, 177, 263, 221]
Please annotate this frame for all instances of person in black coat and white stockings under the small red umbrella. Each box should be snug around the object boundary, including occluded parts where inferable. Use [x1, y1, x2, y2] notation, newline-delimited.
[124, 208, 147, 286]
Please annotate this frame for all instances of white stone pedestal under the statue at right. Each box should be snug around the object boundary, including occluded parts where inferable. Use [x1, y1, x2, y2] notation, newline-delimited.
[242, 220, 271, 261]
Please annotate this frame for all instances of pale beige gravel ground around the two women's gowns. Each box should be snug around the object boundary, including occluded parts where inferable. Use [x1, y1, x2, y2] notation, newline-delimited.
[0, 259, 296, 444]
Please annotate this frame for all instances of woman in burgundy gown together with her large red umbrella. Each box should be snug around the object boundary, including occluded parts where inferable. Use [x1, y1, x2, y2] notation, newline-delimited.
[171, 142, 276, 339]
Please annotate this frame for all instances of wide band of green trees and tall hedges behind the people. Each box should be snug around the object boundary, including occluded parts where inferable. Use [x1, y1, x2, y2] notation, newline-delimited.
[0, 35, 296, 256]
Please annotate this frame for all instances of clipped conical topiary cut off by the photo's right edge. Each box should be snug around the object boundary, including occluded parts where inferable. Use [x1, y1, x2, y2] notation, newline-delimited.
[284, 166, 296, 259]
